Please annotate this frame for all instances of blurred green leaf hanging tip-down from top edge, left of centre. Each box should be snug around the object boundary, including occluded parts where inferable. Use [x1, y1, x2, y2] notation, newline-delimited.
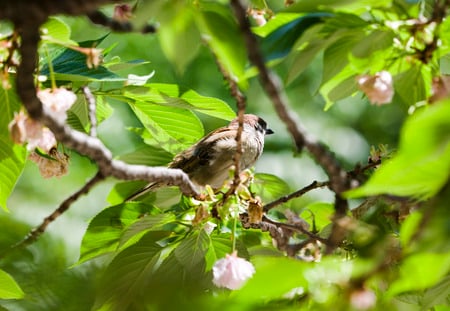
[158, 1, 201, 73]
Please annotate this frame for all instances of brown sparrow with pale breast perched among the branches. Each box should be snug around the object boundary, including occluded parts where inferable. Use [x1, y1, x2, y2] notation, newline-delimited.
[125, 114, 274, 201]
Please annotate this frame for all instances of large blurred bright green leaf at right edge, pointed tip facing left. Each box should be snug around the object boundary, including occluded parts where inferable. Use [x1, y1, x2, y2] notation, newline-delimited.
[347, 100, 450, 199]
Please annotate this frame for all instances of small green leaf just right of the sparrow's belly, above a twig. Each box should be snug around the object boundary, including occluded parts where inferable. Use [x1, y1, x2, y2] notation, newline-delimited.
[251, 173, 290, 208]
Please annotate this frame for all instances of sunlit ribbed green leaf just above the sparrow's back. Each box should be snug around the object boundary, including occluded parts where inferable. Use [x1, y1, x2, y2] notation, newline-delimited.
[131, 101, 203, 154]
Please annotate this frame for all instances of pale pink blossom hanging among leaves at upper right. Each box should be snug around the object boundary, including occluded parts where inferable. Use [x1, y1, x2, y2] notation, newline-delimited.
[357, 70, 394, 105]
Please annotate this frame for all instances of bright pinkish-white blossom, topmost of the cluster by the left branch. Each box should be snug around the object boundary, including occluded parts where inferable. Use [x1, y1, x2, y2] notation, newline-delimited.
[37, 88, 77, 122]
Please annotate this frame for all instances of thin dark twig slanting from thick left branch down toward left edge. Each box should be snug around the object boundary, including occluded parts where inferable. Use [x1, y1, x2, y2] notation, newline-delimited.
[2, 172, 105, 258]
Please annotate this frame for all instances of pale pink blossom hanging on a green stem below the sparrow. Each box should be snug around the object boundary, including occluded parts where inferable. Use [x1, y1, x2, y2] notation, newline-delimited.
[213, 251, 255, 289]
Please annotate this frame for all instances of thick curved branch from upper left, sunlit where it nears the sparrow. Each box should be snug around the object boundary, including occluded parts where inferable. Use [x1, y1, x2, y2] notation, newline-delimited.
[11, 14, 197, 195]
